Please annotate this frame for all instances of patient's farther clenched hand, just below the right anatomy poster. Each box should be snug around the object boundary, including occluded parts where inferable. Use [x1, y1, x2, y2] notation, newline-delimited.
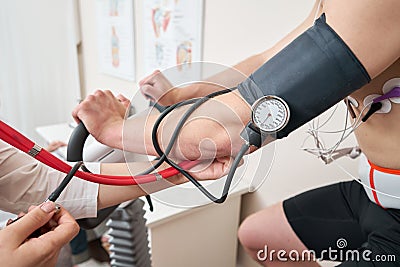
[139, 70, 178, 106]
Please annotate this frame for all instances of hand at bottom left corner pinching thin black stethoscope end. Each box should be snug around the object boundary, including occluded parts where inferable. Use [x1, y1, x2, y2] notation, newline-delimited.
[0, 202, 79, 267]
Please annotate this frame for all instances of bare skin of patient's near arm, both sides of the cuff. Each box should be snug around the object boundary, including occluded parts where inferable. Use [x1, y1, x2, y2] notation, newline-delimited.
[75, 0, 400, 162]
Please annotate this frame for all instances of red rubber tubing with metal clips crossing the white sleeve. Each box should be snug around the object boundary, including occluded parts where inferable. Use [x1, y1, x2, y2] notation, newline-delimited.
[0, 121, 199, 185]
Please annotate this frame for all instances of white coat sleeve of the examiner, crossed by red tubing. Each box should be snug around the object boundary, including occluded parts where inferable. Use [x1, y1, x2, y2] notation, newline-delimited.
[0, 141, 99, 219]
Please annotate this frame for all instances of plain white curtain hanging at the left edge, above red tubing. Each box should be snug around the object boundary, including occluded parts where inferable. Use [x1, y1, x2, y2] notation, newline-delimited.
[0, 0, 80, 140]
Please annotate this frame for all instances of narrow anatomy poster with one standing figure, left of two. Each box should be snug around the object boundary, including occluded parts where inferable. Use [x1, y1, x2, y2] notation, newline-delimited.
[96, 0, 135, 81]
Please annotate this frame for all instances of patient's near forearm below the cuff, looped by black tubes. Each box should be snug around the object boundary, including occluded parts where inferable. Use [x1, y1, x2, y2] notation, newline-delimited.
[119, 91, 251, 160]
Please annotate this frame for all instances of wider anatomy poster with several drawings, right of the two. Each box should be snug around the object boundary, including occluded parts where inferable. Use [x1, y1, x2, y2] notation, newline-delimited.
[143, 0, 203, 79]
